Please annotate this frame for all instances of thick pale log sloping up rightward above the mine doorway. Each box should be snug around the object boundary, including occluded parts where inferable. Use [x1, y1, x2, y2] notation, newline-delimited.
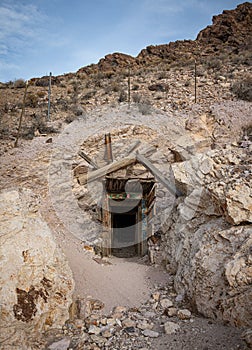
[78, 157, 136, 185]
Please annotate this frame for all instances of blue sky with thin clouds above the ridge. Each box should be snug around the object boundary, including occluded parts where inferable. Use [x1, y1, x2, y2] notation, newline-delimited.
[0, 0, 243, 82]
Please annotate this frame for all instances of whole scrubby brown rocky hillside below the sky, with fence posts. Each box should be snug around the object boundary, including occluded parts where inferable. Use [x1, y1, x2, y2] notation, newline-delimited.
[0, 3, 252, 152]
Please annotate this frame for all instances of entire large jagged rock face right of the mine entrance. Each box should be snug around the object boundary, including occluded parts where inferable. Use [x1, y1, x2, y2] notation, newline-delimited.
[166, 148, 252, 327]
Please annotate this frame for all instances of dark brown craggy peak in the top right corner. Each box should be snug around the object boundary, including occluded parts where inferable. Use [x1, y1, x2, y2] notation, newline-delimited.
[197, 2, 252, 47]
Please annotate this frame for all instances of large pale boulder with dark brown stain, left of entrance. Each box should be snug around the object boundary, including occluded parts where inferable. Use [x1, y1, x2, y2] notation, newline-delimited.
[0, 189, 74, 349]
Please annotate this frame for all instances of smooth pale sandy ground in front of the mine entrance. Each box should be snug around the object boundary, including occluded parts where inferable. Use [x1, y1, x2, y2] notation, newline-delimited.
[44, 202, 169, 314]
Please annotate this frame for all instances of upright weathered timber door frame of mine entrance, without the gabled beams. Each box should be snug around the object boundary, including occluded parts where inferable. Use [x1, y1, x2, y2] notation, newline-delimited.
[102, 176, 156, 257]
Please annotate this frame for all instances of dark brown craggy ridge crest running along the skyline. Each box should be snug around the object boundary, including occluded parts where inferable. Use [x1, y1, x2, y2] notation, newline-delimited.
[78, 2, 252, 74]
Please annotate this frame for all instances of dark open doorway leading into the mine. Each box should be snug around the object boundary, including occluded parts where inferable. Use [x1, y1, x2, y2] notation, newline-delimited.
[112, 212, 138, 258]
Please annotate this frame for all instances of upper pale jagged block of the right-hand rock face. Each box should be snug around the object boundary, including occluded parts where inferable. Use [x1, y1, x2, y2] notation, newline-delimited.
[172, 147, 252, 225]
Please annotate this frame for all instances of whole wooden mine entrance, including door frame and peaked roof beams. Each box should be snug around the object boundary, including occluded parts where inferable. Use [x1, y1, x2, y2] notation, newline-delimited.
[78, 144, 183, 256]
